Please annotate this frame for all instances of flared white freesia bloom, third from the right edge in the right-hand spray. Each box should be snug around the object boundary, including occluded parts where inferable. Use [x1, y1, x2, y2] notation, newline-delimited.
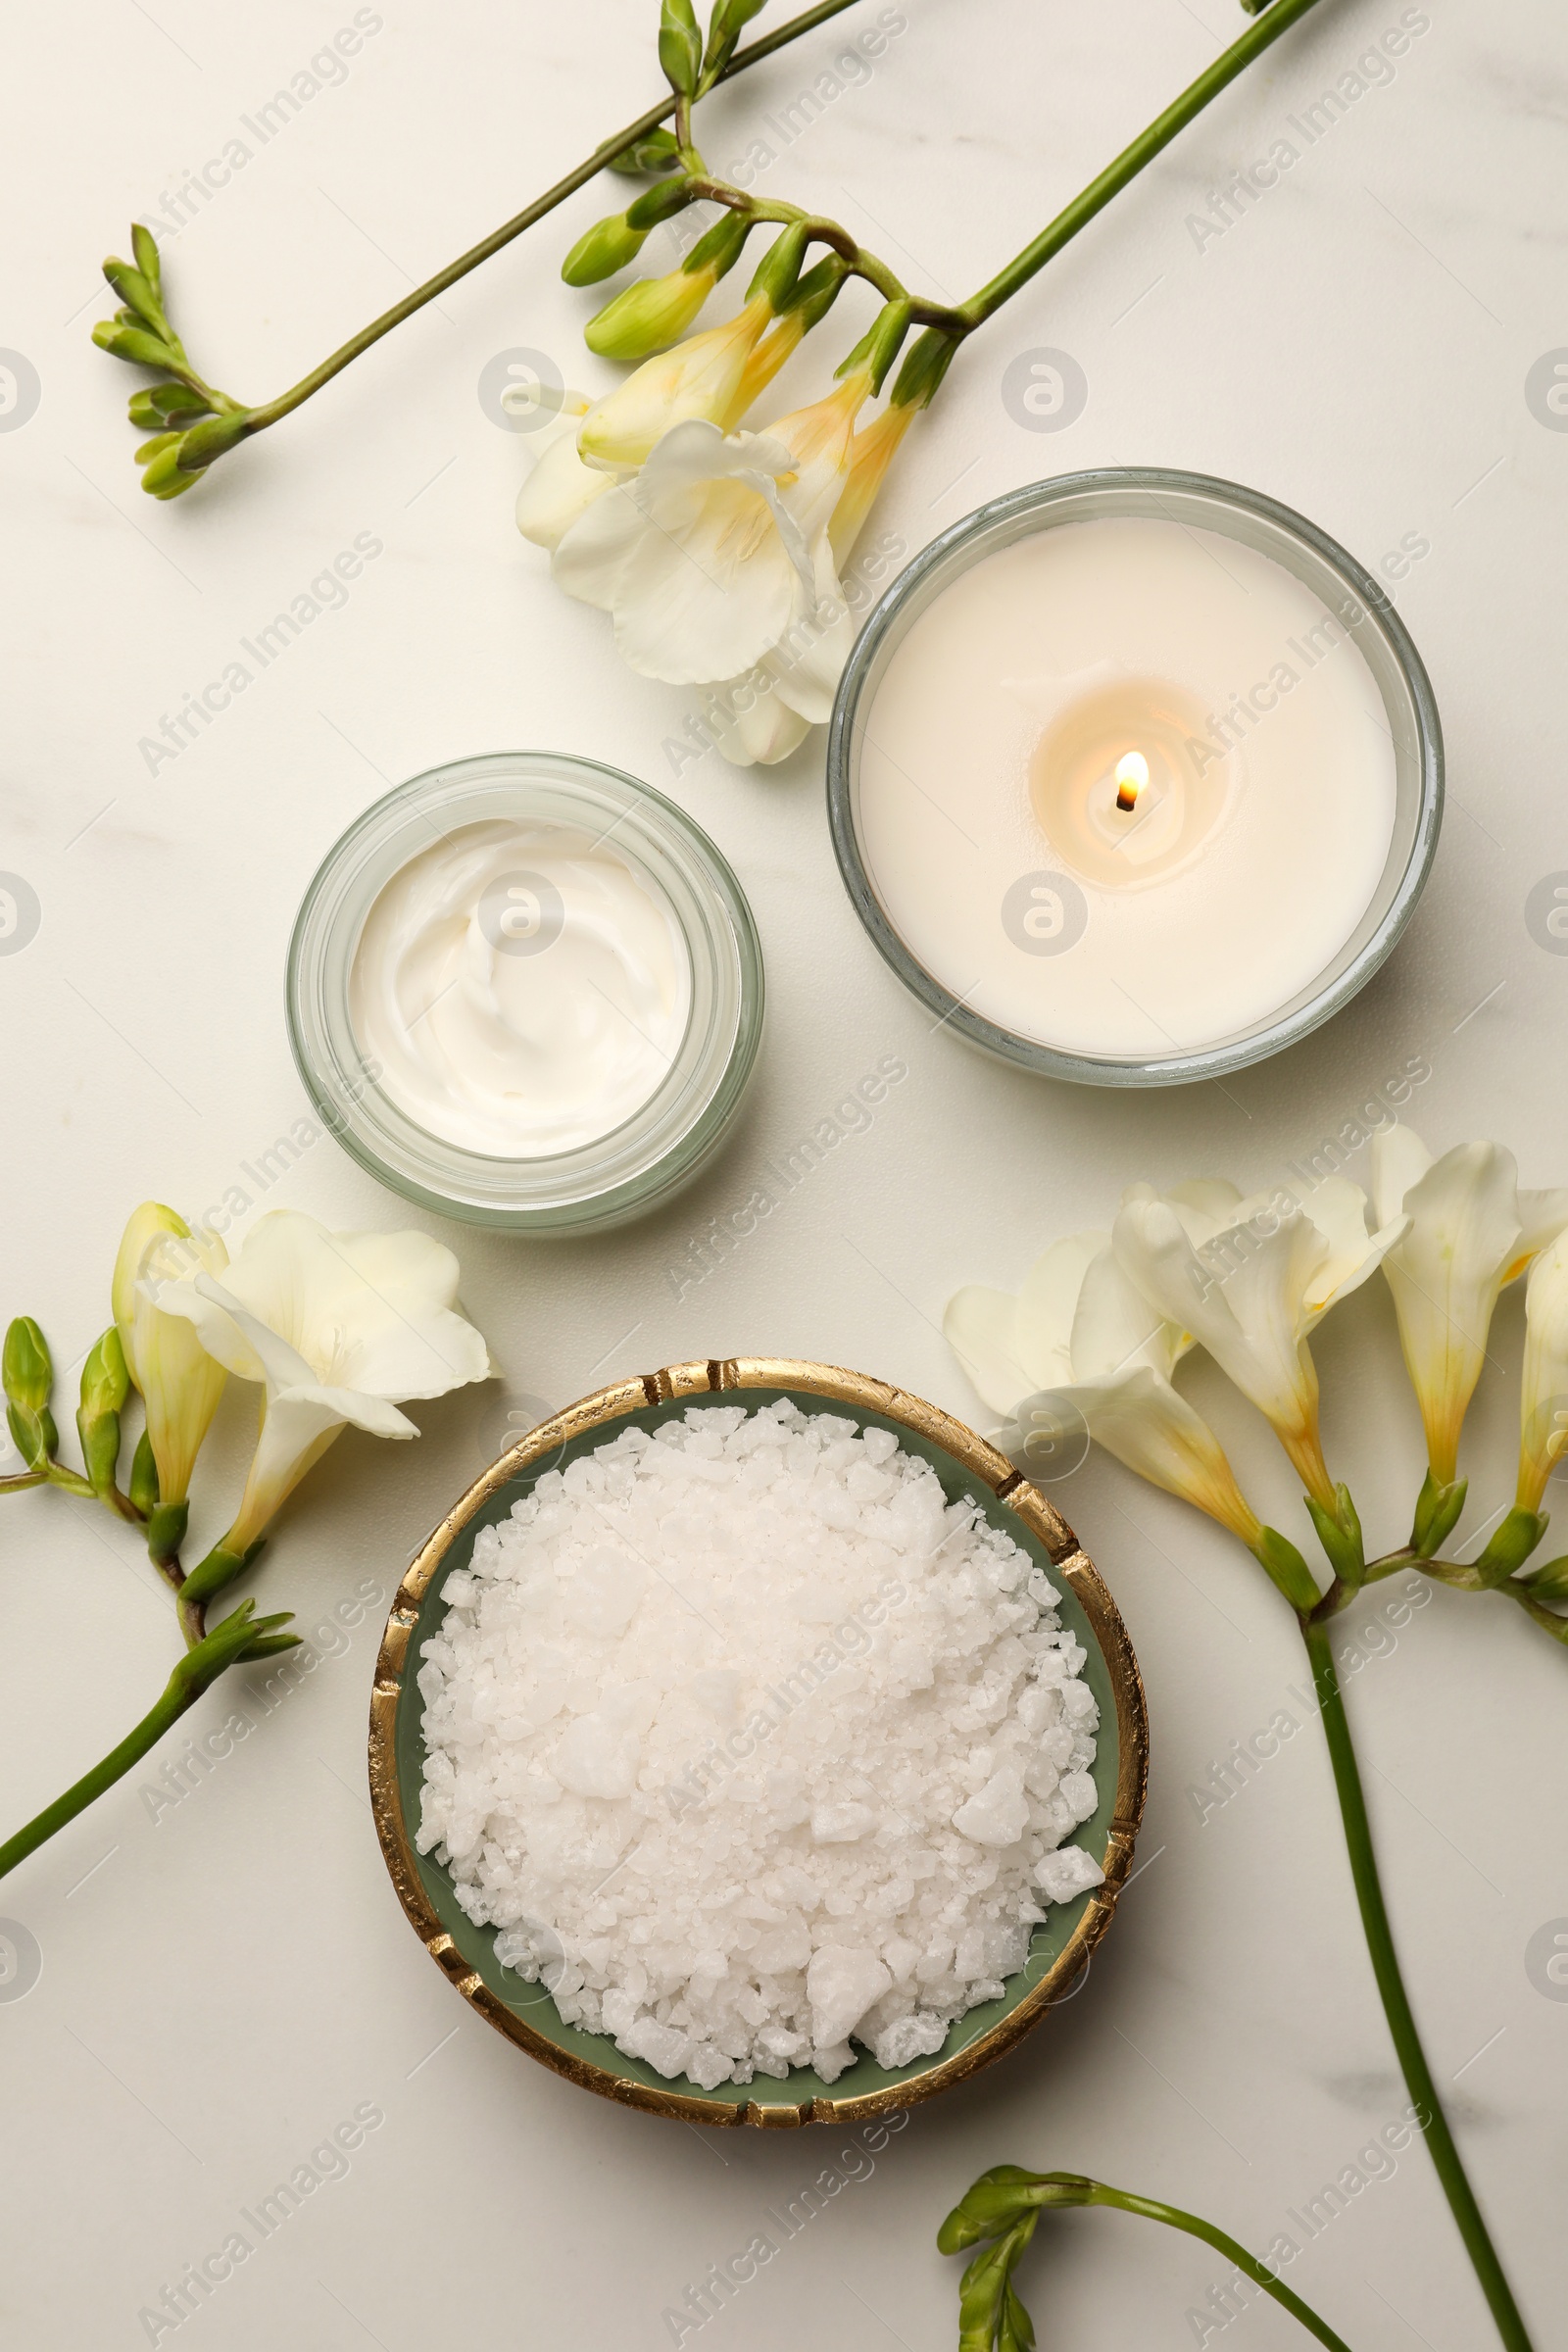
[1112, 1176, 1405, 1507]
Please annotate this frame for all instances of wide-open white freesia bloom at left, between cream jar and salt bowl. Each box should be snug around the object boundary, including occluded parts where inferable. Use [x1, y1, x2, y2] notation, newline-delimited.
[155, 1209, 494, 1554]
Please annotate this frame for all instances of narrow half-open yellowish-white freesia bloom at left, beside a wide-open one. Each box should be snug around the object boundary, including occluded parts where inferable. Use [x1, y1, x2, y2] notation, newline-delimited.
[111, 1200, 228, 1505]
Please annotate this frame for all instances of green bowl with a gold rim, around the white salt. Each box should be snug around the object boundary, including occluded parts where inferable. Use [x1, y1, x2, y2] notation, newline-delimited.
[369, 1357, 1150, 2127]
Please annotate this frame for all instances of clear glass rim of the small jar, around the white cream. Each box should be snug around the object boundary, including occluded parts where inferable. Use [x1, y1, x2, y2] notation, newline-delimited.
[287, 751, 764, 1235]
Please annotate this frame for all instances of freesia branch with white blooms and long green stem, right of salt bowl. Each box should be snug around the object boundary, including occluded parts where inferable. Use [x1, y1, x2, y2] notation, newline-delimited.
[945, 1127, 1568, 2352]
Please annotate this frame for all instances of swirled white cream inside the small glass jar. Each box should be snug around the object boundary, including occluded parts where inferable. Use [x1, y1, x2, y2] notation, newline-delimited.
[348, 818, 691, 1159]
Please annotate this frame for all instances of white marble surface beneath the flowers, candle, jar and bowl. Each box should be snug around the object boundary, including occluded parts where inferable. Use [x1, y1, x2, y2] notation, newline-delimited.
[0, 0, 1568, 2352]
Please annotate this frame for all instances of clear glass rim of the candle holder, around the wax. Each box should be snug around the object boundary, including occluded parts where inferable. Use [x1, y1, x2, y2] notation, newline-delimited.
[827, 466, 1444, 1087]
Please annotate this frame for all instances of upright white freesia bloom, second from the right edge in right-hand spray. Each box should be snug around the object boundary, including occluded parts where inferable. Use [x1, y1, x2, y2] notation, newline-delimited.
[1373, 1127, 1568, 1484]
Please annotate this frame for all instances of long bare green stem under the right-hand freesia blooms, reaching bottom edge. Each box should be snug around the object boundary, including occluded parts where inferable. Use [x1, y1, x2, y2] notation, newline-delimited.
[1277, 1618, 1531, 2352]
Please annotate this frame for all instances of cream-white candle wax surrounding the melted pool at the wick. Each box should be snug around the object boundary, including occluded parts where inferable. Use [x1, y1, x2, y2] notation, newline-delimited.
[860, 517, 1394, 1058]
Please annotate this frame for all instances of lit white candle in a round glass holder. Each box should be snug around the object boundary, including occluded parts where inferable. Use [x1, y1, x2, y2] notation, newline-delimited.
[827, 468, 1444, 1087]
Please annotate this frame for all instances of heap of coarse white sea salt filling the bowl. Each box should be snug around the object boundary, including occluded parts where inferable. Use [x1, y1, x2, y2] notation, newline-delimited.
[418, 1401, 1102, 2088]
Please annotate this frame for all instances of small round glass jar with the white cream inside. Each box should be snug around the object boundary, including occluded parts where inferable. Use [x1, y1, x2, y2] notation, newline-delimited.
[287, 753, 764, 1233]
